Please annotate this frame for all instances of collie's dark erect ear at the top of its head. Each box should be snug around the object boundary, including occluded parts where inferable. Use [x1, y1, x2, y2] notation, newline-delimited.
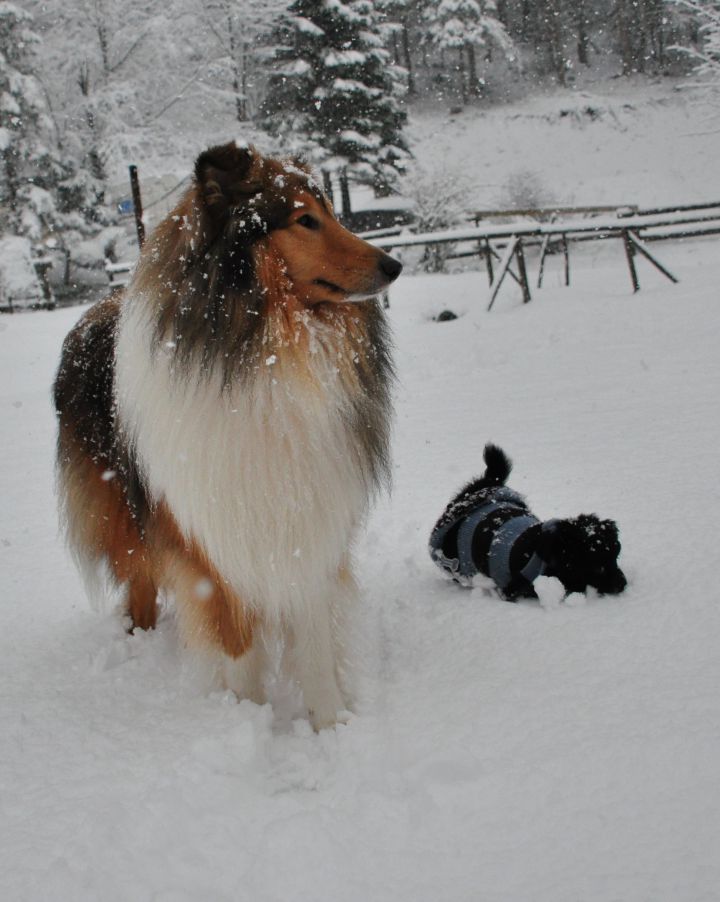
[195, 141, 261, 219]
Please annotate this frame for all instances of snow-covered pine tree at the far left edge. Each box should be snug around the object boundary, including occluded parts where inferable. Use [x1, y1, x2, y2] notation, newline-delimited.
[0, 0, 64, 240]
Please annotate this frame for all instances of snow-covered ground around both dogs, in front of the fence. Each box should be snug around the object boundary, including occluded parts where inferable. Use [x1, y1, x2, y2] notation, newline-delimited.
[0, 222, 720, 902]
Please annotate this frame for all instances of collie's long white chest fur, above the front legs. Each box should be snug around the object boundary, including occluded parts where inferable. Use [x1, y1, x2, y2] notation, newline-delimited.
[116, 308, 369, 615]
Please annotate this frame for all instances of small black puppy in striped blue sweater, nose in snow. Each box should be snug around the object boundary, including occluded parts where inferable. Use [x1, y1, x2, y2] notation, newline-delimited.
[430, 445, 627, 601]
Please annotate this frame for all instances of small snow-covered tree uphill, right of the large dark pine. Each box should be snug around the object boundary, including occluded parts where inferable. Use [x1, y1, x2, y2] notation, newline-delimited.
[425, 0, 514, 103]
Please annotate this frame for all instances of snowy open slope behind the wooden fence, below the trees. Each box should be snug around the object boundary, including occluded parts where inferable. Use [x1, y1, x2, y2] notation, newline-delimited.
[410, 79, 720, 209]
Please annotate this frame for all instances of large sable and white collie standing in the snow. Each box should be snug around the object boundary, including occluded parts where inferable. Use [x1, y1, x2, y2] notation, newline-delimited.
[54, 143, 402, 729]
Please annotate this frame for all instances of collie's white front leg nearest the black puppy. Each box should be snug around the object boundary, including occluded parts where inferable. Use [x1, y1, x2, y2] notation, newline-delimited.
[285, 583, 354, 730]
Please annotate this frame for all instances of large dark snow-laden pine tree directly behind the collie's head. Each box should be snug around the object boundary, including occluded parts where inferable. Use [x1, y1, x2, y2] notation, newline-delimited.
[260, 0, 408, 193]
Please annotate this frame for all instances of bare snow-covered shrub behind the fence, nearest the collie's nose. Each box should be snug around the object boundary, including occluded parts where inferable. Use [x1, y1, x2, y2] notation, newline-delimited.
[399, 164, 472, 272]
